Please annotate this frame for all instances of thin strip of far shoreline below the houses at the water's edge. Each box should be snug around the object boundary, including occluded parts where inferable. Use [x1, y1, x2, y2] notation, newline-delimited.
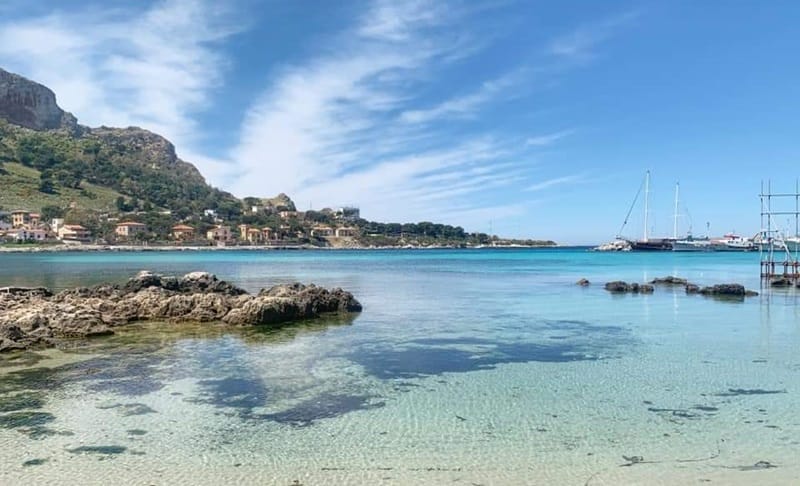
[0, 245, 560, 254]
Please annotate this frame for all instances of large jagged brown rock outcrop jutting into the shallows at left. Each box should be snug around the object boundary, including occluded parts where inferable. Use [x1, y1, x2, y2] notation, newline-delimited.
[0, 271, 362, 352]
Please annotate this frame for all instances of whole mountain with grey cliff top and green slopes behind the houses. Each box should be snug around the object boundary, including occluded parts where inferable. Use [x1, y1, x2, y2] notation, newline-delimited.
[0, 69, 242, 217]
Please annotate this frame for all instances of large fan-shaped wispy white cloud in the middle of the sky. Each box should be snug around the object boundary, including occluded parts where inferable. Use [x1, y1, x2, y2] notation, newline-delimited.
[231, 2, 528, 223]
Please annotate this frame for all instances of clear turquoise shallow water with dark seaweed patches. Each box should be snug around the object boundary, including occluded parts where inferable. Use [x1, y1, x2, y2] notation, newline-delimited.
[0, 249, 800, 485]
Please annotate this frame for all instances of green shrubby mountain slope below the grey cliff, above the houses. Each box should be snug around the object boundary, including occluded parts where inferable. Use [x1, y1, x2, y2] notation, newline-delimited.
[0, 121, 241, 218]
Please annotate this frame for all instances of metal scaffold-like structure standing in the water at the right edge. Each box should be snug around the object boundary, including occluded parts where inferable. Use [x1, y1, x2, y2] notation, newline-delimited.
[756, 180, 800, 280]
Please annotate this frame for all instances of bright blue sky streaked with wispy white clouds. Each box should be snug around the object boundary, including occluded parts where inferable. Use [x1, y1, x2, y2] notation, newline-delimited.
[0, 0, 800, 244]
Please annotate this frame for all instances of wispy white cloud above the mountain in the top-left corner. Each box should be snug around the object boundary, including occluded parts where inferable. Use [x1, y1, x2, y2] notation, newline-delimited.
[0, 0, 242, 162]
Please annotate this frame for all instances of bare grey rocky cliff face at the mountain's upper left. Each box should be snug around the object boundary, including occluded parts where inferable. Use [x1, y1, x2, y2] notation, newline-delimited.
[0, 69, 78, 130]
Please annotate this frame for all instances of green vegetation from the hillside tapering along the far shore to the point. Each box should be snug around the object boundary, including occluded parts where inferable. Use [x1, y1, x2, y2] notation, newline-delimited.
[0, 120, 553, 246]
